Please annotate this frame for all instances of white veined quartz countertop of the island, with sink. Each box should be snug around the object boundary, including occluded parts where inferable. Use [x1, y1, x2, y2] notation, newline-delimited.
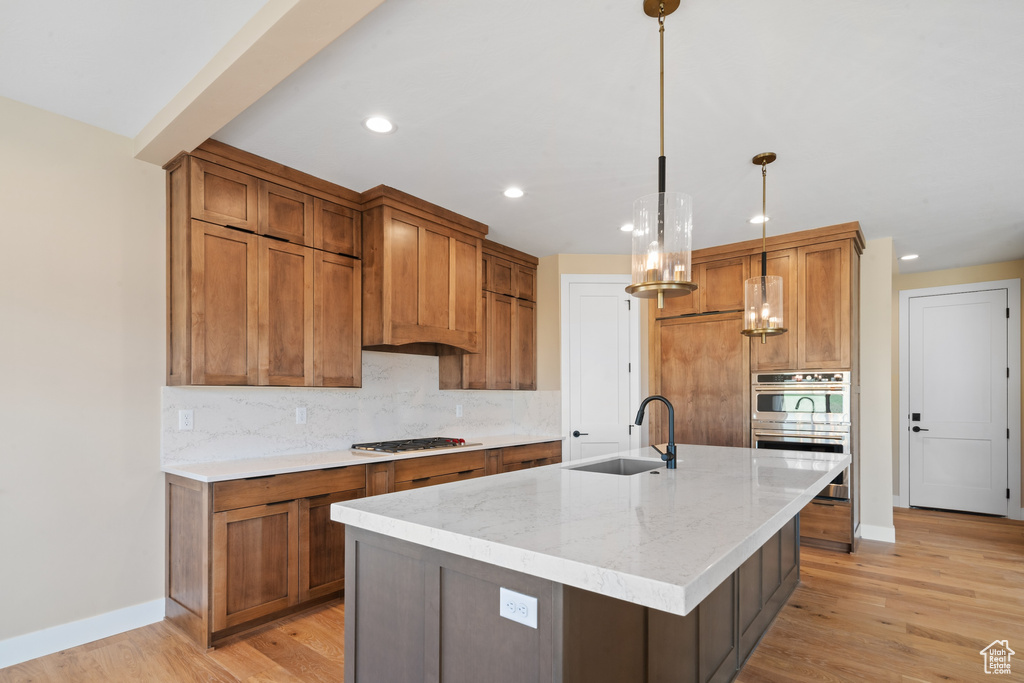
[331, 445, 850, 615]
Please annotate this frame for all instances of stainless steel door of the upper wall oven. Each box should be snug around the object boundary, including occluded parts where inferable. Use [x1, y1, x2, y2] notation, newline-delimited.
[751, 384, 850, 425]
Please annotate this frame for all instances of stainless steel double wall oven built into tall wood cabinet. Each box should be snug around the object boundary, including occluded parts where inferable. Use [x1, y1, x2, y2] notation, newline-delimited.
[751, 371, 851, 500]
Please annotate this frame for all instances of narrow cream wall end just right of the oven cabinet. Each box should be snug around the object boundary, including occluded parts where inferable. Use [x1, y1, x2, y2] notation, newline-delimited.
[858, 238, 896, 539]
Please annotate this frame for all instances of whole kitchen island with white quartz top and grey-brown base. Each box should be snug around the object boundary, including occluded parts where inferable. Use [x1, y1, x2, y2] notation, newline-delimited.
[331, 445, 850, 683]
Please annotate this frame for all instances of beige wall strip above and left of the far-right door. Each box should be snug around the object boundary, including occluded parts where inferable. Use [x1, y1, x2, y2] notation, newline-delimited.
[892, 260, 1024, 495]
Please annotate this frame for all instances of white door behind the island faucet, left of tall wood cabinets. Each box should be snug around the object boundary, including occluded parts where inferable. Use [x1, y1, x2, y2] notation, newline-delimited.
[562, 275, 640, 460]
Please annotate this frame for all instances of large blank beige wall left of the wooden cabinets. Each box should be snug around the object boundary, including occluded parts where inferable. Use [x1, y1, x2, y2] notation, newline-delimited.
[0, 98, 165, 640]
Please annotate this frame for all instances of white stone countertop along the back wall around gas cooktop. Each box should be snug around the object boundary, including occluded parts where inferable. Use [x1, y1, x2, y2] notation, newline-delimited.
[160, 434, 562, 483]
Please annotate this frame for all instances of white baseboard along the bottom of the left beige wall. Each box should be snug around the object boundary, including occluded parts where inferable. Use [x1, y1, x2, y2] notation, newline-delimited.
[0, 598, 164, 669]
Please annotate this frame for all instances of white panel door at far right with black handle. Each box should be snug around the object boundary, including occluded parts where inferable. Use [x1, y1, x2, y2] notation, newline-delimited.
[906, 290, 1009, 515]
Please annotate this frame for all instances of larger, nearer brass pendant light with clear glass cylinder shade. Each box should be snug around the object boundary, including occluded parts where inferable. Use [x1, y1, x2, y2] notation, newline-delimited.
[626, 0, 697, 308]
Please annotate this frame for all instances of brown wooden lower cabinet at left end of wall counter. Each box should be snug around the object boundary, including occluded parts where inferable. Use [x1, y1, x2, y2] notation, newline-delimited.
[166, 465, 367, 647]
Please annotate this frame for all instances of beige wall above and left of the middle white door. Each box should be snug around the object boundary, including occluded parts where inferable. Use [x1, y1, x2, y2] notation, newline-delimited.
[537, 254, 630, 391]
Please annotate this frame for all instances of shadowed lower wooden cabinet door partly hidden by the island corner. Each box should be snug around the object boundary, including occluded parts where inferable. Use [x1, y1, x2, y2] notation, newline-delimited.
[299, 488, 366, 601]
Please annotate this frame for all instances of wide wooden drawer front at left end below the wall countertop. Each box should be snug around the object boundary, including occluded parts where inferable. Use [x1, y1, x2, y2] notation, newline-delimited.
[213, 465, 367, 512]
